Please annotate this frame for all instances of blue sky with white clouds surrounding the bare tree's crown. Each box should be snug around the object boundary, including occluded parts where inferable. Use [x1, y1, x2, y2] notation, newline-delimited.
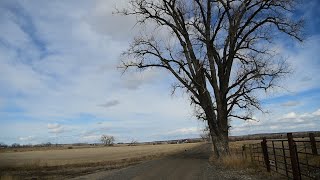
[0, 0, 320, 144]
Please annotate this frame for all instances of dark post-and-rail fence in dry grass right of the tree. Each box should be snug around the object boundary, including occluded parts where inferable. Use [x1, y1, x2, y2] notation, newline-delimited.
[243, 133, 320, 180]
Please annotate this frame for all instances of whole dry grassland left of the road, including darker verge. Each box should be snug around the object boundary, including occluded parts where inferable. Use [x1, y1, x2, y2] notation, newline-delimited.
[0, 143, 203, 179]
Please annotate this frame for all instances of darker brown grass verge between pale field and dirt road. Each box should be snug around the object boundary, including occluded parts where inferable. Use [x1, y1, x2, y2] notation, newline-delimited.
[0, 154, 167, 179]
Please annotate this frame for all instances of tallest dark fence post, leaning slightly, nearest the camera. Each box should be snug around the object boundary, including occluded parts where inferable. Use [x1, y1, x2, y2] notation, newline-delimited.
[287, 133, 301, 180]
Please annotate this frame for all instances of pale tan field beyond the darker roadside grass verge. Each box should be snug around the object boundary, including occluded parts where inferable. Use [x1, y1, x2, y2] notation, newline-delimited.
[0, 143, 199, 168]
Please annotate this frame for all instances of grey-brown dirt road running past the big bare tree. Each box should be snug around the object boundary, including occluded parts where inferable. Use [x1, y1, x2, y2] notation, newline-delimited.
[74, 144, 276, 180]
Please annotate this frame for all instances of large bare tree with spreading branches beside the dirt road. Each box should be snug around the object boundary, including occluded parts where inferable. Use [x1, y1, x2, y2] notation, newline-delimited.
[118, 0, 302, 157]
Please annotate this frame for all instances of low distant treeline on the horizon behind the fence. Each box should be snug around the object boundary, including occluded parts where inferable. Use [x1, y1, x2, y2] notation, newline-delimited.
[229, 131, 320, 141]
